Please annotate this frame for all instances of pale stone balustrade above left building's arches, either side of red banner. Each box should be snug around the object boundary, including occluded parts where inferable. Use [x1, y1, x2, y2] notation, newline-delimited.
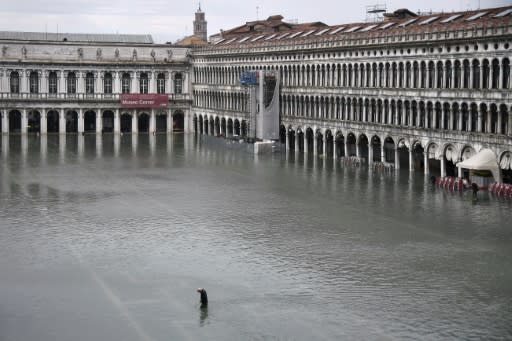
[0, 92, 191, 101]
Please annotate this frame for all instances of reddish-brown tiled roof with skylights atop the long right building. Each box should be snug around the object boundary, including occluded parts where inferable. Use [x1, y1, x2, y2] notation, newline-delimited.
[208, 6, 512, 48]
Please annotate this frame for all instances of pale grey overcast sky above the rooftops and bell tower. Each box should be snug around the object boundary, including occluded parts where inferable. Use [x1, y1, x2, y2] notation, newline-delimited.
[0, 0, 512, 43]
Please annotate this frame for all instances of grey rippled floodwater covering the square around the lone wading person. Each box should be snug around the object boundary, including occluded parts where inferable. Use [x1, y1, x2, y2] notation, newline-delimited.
[0, 134, 512, 341]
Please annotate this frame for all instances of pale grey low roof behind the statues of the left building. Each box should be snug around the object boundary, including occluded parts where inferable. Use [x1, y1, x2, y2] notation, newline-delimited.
[0, 31, 153, 44]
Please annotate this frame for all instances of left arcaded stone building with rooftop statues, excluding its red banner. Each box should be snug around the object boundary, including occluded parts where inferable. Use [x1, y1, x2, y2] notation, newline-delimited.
[0, 32, 191, 134]
